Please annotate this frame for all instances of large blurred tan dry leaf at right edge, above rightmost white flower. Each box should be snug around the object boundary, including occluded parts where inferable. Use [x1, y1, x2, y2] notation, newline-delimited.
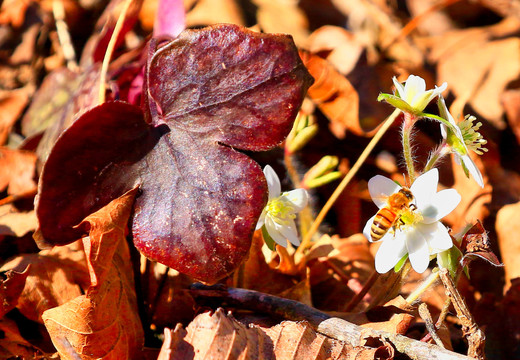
[424, 20, 520, 129]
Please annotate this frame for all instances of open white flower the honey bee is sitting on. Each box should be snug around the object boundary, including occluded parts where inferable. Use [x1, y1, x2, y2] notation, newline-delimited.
[363, 169, 461, 273]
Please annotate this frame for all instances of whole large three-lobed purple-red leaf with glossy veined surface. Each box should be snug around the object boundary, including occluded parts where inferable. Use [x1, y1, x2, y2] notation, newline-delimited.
[37, 25, 312, 282]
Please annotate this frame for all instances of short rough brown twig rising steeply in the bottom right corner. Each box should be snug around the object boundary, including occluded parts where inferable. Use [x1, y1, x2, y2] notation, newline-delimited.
[440, 269, 486, 359]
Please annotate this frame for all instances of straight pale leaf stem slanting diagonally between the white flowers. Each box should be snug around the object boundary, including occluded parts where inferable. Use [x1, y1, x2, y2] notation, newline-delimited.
[297, 109, 401, 253]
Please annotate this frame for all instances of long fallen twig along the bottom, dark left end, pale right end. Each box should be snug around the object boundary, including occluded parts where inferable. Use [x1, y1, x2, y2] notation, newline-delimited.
[191, 284, 476, 360]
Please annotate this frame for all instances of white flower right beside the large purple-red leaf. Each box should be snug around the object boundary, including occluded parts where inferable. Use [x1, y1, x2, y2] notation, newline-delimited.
[256, 165, 308, 247]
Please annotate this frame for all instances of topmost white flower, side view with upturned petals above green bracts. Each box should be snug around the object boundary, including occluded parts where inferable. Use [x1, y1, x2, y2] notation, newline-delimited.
[378, 75, 448, 114]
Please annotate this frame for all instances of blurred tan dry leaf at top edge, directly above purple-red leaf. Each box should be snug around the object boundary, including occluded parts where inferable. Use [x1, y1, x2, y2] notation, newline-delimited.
[184, 0, 245, 27]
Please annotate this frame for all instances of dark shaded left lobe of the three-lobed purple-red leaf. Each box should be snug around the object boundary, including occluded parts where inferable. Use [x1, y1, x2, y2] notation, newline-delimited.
[36, 102, 156, 246]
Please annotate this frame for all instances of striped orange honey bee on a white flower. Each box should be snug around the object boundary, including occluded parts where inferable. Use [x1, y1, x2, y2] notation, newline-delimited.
[370, 187, 415, 241]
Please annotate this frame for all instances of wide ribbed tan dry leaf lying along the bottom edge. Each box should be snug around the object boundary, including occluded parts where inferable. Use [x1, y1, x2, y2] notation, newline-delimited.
[172, 309, 377, 360]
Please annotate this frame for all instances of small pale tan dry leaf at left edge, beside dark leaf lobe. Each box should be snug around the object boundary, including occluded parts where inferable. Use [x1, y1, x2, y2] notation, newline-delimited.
[0, 204, 38, 237]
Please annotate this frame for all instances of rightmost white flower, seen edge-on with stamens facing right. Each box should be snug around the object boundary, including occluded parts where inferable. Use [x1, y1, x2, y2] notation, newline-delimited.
[437, 96, 487, 187]
